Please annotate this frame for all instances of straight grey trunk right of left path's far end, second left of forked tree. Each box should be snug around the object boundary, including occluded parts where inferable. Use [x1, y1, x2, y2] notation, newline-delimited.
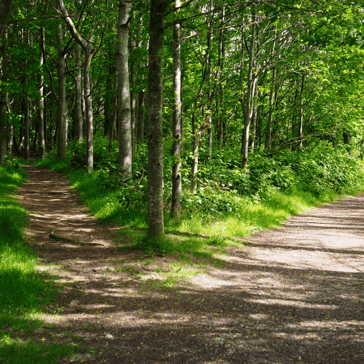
[56, 24, 67, 159]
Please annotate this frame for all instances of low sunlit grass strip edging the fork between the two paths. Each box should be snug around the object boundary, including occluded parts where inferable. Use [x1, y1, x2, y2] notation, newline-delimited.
[37, 159, 357, 259]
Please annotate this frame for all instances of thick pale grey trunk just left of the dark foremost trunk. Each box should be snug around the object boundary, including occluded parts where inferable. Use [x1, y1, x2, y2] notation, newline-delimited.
[116, 3, 133, 178]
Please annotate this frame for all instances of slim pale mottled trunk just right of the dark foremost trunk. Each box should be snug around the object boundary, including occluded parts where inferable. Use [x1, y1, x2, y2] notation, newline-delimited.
[171, 0, 182, 217]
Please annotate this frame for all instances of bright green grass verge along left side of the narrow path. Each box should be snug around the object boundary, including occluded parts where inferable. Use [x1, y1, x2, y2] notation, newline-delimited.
[0, 166, 81, 364]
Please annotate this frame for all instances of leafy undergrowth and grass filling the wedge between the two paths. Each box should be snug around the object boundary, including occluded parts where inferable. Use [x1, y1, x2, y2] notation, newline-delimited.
[38, 135, 364, 258]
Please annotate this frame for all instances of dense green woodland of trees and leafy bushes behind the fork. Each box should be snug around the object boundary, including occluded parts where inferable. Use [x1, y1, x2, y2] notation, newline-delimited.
[0, 0, 364, 239]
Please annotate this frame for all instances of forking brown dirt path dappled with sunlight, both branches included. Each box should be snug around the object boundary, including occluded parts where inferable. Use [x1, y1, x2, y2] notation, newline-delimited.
[18, 167, 364, 364]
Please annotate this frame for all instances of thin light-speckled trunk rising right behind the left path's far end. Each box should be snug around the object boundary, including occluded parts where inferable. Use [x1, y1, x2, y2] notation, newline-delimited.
[38, 27, 46, 160]
